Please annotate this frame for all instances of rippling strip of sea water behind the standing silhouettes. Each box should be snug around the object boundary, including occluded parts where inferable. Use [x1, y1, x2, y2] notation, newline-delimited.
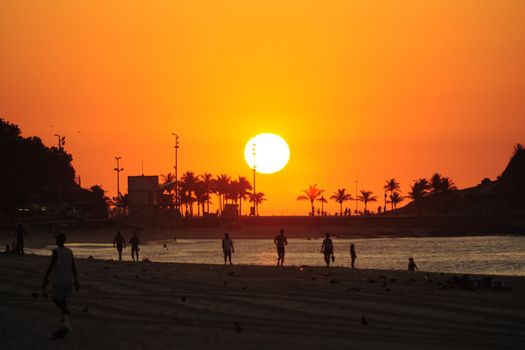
[26, 236, 525, 276]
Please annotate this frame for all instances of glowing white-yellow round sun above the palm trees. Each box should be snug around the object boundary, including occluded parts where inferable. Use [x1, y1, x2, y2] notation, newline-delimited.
[244, 133, 290, 174]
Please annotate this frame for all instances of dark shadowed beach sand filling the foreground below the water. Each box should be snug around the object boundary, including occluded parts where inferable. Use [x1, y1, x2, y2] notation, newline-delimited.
[0, 256, 525, 349]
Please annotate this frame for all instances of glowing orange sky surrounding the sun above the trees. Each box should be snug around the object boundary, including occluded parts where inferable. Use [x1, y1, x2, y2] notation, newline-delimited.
[0, 0, 525, 215]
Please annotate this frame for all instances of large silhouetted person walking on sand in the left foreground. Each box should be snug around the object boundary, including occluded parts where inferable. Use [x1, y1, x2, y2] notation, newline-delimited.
[42, 234, 79, 333]
